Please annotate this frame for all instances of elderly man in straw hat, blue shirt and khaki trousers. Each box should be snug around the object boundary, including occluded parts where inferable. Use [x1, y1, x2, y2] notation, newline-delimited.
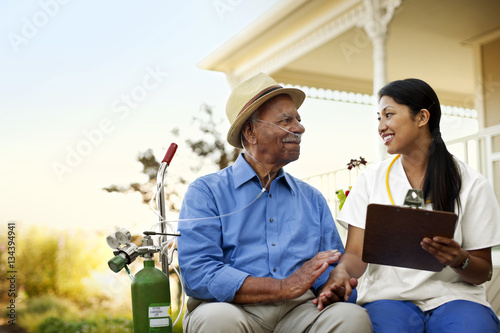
[178, 73, 372, 333]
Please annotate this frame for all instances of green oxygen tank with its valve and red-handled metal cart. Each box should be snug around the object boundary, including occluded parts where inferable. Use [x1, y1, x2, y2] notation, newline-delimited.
[106, 143, 180, 333]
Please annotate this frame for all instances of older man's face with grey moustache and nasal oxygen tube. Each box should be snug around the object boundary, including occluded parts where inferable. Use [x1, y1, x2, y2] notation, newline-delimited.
[255, 95, 305, 167]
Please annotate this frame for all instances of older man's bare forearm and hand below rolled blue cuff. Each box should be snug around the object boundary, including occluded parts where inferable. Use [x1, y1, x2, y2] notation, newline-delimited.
[233, 250, 340, 304]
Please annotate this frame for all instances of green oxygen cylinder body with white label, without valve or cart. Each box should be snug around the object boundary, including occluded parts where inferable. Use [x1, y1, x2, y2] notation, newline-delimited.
[132, 259, 173, 333]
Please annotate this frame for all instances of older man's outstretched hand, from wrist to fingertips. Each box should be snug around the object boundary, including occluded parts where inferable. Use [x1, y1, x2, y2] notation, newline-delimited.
[280, 250, 341, 299]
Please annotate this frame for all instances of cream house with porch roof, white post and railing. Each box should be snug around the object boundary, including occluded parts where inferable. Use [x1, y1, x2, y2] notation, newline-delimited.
[199, 0, 500, 314]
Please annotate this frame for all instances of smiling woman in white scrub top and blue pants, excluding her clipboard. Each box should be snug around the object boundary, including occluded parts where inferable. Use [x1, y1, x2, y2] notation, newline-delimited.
[315, 79, 500, 333]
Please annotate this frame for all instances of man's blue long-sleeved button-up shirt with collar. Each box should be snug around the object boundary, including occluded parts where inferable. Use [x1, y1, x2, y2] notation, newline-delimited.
[178, 155, 344, 302]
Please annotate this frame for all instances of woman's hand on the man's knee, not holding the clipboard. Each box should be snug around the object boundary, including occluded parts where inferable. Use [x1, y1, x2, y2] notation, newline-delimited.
[313, 266, 358, 311]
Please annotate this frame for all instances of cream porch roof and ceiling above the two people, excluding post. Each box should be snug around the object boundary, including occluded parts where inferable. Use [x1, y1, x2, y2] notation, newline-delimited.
[199, 0, 500, 108]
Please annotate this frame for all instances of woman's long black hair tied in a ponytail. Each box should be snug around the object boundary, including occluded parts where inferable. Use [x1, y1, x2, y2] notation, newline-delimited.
[378, 79, 462, 212]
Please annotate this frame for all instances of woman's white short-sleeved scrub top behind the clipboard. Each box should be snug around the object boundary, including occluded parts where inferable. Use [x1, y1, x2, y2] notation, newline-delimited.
[337, 158, 500, 311]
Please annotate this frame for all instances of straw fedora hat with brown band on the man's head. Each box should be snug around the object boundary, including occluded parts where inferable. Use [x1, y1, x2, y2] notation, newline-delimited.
[226, 73, 306, 148]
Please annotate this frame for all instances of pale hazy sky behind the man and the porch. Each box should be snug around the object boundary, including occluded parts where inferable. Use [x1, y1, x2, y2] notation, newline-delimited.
[0, 0, 476, 231]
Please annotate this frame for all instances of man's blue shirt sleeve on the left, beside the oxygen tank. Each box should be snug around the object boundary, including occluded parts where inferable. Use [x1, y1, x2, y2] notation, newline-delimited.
[178, 182, 249, 302]
